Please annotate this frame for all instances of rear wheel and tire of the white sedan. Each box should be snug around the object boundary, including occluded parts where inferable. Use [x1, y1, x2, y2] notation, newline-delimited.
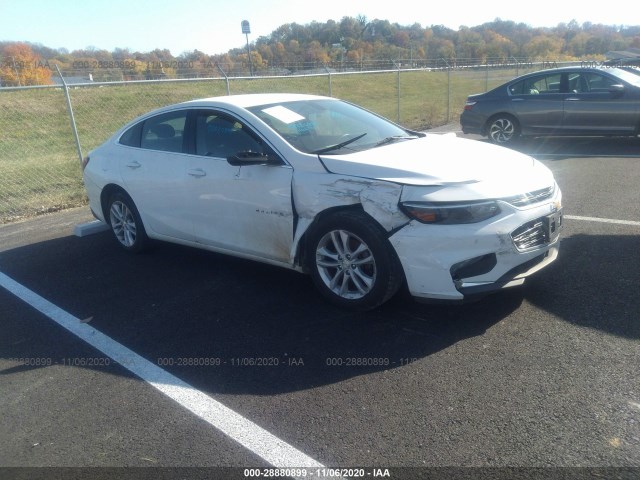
[107, 192, 148, 253]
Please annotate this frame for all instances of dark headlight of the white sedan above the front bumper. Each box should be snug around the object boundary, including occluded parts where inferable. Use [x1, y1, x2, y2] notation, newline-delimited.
[400, 201, 500, 225]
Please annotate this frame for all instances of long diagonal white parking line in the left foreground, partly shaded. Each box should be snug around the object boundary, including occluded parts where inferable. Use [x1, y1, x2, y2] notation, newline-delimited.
[0, 272, 324, 478]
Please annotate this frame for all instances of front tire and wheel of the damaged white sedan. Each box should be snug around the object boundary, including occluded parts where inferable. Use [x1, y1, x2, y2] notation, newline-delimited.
[308, 212, 402, 310]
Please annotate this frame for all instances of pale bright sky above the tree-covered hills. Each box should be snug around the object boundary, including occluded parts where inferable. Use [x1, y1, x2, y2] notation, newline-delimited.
[0, 0, 640, 55]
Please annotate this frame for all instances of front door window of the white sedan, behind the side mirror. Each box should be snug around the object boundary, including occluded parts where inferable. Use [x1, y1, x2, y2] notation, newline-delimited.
[196, 111, 267, 158]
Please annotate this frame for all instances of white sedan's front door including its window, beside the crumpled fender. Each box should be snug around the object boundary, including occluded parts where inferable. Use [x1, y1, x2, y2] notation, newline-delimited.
[188, 110, 293, 262]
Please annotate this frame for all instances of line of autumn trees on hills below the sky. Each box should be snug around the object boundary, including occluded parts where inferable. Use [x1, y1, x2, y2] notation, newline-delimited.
[0, 15, 640, 86]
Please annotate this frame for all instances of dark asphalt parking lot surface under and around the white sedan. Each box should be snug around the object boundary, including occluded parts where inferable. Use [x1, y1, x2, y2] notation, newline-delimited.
[0, 132, 640, 479]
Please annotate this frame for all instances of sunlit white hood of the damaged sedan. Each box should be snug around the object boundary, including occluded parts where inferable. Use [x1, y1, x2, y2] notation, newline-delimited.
[320, 134, 553, 194]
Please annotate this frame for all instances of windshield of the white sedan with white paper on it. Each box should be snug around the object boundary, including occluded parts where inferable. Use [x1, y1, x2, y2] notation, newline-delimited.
[249, 99, 416, 155]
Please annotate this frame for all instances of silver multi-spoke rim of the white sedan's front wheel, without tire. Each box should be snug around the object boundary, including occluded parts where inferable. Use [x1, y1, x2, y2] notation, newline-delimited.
[316, 230, 376, 300]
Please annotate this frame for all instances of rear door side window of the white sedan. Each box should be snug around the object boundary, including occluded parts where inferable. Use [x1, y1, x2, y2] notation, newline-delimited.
[140, 110, 187, 153]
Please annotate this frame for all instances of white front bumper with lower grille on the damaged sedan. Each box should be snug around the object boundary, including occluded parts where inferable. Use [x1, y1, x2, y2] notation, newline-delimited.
[389, 194, 562, 301]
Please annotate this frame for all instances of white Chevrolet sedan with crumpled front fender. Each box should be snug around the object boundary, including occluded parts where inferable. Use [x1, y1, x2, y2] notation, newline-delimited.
[83, 94, 562, 309]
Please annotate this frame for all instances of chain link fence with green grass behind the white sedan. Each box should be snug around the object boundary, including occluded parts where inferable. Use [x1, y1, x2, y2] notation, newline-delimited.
[0, 63, 556, 224]
